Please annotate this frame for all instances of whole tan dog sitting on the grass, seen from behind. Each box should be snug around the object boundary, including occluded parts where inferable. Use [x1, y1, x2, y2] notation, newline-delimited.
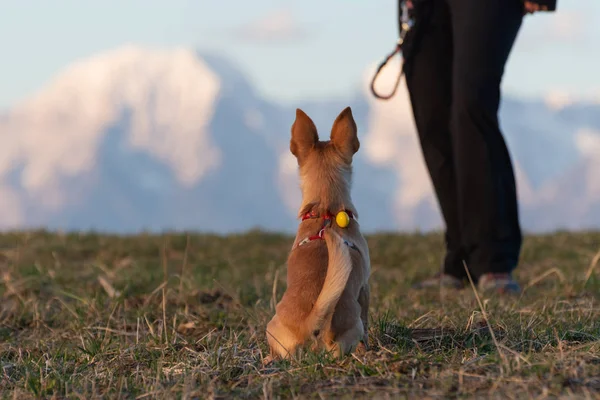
[265, 107, 371, 361]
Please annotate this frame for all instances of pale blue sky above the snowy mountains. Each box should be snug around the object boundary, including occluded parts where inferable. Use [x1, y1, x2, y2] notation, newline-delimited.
[0, 0, 600, 108]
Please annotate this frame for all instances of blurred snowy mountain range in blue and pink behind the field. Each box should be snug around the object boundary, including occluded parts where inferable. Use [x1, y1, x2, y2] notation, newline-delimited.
[0, 47, 600, 233]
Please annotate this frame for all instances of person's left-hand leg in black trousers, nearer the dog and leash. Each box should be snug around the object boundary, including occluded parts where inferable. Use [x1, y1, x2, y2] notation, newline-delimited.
[405, 0, 465, 287]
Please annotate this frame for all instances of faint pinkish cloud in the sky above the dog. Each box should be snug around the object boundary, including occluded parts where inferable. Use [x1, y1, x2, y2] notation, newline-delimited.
[234, 9, 308, 42]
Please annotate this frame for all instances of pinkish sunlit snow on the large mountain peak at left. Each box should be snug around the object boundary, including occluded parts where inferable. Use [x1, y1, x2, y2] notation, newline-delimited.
[0, 46, 221, 195]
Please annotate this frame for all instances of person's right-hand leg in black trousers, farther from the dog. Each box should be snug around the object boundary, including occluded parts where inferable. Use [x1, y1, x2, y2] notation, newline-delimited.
[448, 0, 523, 290]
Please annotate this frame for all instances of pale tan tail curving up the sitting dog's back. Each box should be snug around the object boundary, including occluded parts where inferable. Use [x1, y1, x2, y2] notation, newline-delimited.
[307, 229, 352, 336]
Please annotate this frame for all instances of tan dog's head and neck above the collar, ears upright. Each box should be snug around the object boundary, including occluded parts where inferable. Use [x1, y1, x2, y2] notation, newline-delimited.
[290, 107, 360, 213]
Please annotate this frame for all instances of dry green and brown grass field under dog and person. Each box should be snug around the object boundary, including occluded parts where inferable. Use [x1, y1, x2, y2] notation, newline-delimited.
[0, 232, 600, 399]
